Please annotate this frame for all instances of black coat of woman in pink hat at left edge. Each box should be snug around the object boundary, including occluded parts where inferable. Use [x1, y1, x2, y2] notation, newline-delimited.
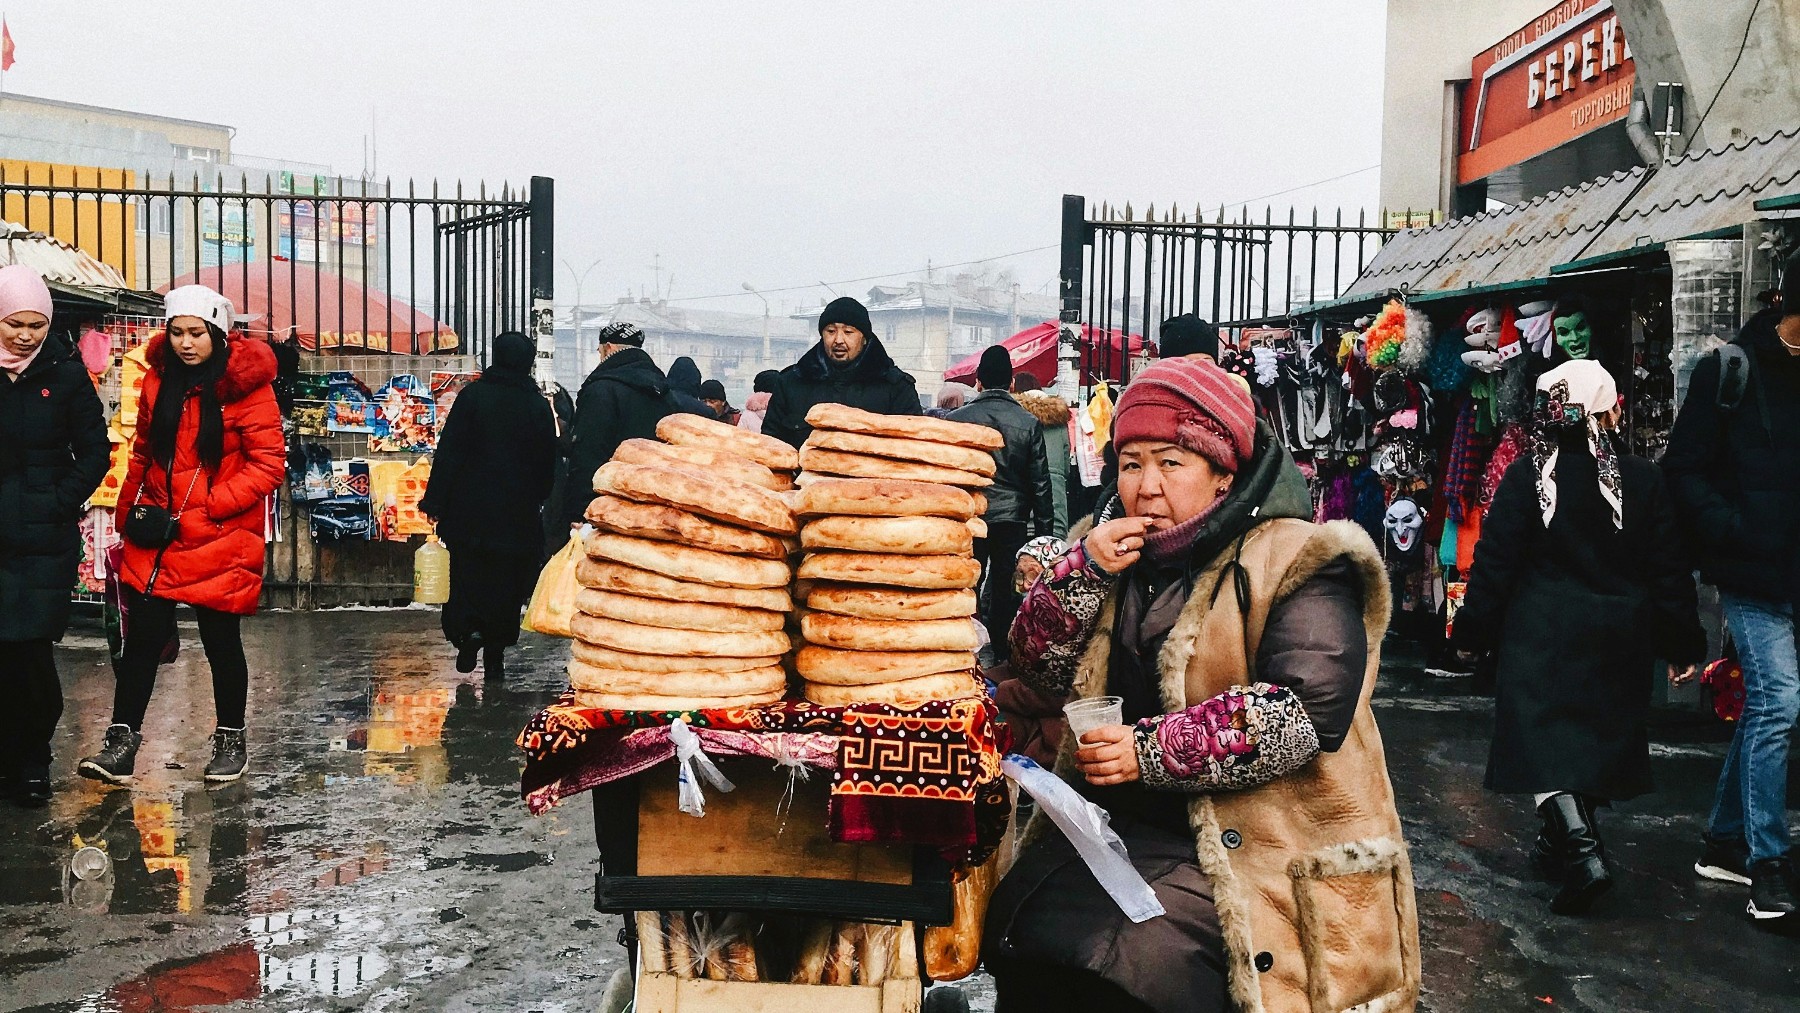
[0, 335, 112, 641]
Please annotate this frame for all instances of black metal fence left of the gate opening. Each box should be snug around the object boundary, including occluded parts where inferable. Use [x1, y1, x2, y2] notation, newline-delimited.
[0, 166, 554, 367]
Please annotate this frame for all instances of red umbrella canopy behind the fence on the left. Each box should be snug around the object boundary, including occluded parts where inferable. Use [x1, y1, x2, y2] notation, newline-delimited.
[158, 257, 457, 354]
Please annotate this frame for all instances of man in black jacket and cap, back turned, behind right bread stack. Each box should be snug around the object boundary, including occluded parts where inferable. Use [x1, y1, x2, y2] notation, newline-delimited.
[950, 345, 1057, 664]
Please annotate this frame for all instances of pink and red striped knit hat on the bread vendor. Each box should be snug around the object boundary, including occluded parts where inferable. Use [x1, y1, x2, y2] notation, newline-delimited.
[1112, 358, 1256, 473]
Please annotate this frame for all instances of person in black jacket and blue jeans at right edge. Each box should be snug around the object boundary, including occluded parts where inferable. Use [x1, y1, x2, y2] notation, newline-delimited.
[1663, 259, 1800, 921]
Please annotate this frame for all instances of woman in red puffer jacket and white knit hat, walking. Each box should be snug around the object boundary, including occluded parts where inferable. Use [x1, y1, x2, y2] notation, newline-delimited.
[79, 284, 286, 784]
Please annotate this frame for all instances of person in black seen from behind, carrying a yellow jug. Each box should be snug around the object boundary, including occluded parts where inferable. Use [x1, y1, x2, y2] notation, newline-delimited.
[419, 331, 556, 678]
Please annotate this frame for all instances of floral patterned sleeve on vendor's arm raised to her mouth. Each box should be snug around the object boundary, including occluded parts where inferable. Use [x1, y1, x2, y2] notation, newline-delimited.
[1008, 542, 1112, 696]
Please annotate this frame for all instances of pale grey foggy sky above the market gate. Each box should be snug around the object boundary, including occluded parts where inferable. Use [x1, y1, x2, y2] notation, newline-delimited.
[5, 0, 1384, 311]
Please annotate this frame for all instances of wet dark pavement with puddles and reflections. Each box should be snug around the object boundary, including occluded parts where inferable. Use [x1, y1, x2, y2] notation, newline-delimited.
[0, 610, 1800, 1013]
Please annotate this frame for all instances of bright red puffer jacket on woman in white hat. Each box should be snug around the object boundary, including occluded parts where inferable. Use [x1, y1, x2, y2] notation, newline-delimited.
[117, 335, 288, 615]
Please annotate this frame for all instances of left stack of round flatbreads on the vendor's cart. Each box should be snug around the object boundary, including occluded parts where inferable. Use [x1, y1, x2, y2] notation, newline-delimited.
[569, 414, 799, 711]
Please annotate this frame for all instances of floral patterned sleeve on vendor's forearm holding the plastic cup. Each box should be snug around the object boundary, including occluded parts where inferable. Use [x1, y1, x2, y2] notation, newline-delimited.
[1137, 687, 1319, 792]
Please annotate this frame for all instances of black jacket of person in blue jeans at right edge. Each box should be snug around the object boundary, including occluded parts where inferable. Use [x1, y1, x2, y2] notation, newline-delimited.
[1663, 309, 1800, 603]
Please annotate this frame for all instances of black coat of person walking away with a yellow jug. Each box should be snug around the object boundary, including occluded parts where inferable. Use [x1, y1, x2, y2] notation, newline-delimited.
[419, 369, 556, 560]
